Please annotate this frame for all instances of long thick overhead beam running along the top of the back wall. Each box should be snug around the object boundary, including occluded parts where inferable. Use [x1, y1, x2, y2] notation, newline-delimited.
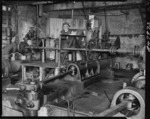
[43, 0, 142, 12]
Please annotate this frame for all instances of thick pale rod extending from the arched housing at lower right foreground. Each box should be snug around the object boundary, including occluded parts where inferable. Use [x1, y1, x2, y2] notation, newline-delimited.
[94, 101, 129, 117]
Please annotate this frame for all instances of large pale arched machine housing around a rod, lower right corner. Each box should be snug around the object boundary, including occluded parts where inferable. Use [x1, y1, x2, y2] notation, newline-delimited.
[111, 87, 145, 119]
